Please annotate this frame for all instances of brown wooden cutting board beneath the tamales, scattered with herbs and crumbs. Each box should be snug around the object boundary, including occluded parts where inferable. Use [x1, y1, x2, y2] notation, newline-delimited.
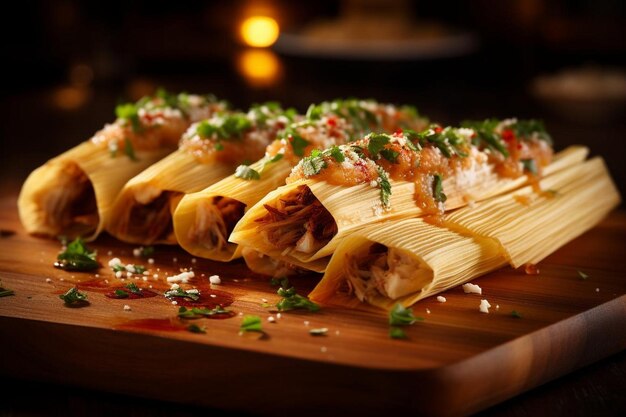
[0, 198, 626, 416]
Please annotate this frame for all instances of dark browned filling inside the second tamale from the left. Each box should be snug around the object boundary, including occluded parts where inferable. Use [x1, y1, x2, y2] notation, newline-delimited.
[126, 191, 181, 244]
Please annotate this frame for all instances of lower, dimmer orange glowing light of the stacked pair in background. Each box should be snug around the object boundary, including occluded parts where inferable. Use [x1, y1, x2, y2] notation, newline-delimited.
[238, 49, 281, 87]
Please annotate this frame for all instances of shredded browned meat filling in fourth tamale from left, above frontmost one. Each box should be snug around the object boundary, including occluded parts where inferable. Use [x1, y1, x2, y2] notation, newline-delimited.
[256, 185, 337, 253]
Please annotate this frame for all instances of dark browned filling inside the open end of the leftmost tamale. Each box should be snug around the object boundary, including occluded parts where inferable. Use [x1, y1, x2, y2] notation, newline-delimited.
[45, 164, 100, 237]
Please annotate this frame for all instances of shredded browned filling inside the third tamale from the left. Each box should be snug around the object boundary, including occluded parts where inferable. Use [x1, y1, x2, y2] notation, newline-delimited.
[189, 196, 246, 251]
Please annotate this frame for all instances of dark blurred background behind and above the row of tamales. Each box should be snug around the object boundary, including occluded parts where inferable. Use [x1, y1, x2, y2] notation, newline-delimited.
[0, 0, 626, 202]
